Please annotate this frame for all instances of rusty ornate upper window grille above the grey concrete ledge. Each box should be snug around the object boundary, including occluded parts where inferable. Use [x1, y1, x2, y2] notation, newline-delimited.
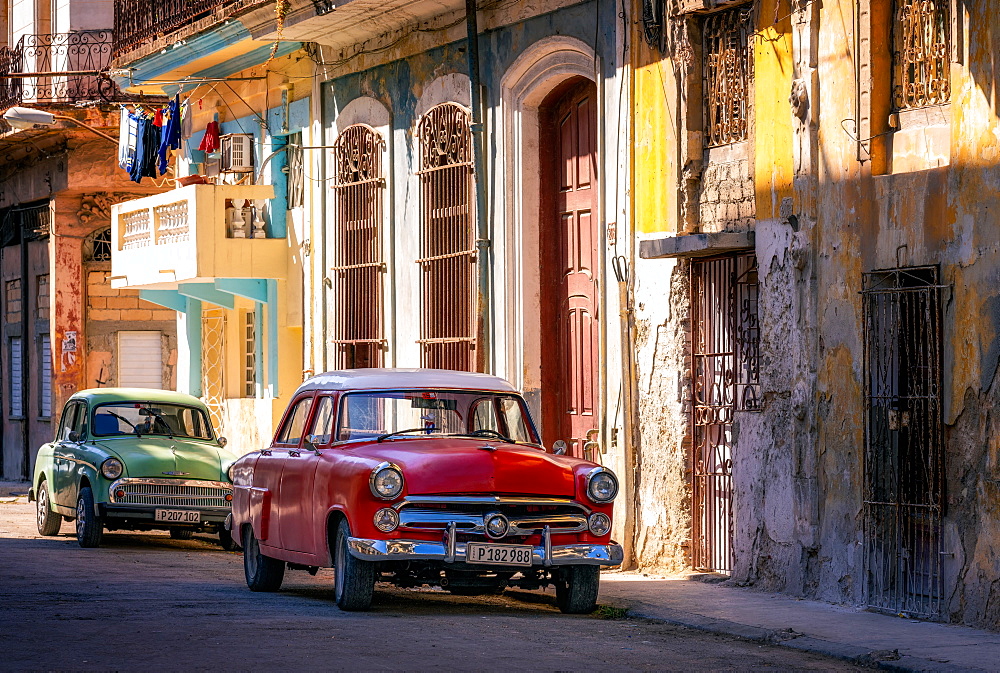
[702, 4, 756, 147]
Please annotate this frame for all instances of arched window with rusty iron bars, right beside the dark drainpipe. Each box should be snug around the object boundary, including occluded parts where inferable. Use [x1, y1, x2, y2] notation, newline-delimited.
[417, 103, 476, 371]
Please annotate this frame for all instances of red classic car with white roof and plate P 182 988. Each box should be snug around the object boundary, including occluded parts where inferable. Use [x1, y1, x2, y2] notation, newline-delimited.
[227, 369, 622, 613]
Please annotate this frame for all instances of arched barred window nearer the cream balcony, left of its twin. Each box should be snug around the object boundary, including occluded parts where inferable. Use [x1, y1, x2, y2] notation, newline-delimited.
[331, 124, 385, 369]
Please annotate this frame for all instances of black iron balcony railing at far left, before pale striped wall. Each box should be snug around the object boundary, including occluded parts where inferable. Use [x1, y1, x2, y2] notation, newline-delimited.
[0, 30, 132, 109]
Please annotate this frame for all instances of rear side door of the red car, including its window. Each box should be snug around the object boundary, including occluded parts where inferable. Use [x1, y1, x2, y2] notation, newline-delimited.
[250, 393, 312, 548]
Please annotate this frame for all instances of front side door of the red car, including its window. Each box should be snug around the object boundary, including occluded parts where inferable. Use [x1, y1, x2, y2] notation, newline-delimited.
[278, 395, 334, 553]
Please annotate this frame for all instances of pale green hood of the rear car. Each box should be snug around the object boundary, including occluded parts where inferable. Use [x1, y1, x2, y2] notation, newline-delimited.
[100, 437, 233, 481]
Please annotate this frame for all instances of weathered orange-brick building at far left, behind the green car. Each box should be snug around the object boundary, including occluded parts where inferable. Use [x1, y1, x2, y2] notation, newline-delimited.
[0, 0, 175, 479]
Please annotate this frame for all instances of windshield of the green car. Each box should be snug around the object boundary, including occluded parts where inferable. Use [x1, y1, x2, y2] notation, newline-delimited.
[91, 402, 212, 440]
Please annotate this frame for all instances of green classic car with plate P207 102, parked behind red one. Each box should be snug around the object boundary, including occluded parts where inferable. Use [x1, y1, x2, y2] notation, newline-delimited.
[28, 388, 239, 549]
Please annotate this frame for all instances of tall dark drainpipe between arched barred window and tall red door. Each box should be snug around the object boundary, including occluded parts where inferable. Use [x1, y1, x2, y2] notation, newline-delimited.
[465, 0, 493, 373]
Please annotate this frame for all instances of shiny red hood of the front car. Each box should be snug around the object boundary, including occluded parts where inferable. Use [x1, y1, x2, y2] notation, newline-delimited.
[352, 438, 578, 497]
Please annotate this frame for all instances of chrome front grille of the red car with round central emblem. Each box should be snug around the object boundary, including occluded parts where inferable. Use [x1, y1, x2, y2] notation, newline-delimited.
[395, 496, 590, 536]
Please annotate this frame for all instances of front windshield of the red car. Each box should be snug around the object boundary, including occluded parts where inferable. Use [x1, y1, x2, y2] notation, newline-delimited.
[336, 390, 538, 444]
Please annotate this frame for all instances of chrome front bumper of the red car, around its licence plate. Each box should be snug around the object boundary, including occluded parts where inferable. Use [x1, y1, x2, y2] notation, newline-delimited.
[347, 527, 625, 567]
